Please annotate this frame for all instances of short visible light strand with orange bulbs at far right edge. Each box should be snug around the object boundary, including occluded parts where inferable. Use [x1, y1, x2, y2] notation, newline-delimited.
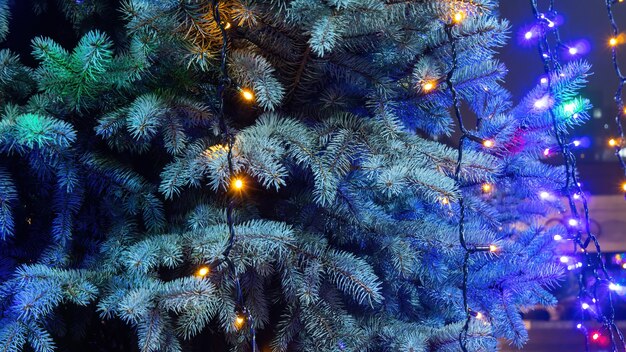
[605, 0, 626, 179]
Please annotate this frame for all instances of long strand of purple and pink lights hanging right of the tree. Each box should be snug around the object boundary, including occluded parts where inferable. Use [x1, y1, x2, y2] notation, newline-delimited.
[531, 0, 626, 351]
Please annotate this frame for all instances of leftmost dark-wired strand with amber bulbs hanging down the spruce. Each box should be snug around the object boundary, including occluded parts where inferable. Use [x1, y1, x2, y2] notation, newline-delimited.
[213, 0, 258, 352]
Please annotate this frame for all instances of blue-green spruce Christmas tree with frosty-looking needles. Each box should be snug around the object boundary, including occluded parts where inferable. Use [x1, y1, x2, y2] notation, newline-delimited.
[0, 0, 589, 352]
